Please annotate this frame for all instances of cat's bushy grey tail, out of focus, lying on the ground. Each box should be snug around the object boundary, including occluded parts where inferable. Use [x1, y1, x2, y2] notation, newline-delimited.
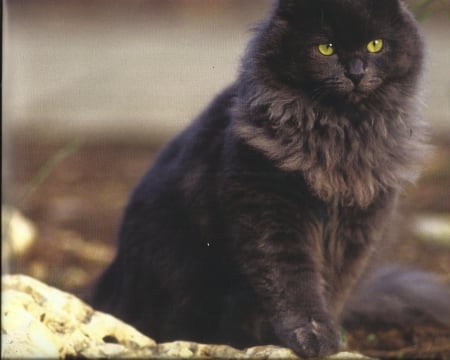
[342, 265, 450, 329]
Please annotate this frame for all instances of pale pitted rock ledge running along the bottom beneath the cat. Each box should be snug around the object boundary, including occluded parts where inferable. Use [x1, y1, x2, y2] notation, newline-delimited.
[1, 275, 367, 359]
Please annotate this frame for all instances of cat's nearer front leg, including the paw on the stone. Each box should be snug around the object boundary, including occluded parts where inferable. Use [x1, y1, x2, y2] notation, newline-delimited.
[225, 194, 339, 357]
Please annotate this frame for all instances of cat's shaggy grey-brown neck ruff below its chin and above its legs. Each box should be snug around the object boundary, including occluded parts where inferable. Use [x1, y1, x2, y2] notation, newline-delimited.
[234, 95, 420, 208]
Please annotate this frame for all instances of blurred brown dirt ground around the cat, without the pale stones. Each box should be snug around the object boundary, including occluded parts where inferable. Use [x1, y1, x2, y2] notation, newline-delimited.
[3, 133, 450, 359]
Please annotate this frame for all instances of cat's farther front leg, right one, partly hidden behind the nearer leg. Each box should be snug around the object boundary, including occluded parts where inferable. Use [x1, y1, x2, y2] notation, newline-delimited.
[323, 189, 398, 318]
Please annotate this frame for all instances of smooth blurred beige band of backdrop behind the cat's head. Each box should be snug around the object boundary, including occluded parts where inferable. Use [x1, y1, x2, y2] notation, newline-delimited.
[3, 0, 450, 141]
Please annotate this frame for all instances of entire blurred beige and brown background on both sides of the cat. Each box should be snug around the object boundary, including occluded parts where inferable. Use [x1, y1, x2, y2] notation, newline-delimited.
[2, 0, 450, 354]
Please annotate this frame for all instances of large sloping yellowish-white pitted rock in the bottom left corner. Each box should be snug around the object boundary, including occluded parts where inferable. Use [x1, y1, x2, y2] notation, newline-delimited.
[2, 275, 156, 358]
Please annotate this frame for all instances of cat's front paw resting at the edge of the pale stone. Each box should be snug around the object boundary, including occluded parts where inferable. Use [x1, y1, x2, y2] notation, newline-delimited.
[286, 319, 339, 357]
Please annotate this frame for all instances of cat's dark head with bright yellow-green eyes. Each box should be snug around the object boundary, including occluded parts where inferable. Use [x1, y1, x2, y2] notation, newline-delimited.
[248, 0, 423, 103]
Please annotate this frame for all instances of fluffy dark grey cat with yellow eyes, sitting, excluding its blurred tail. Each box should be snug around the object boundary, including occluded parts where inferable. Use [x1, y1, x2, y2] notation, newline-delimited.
[93, 0, 446, 356]
